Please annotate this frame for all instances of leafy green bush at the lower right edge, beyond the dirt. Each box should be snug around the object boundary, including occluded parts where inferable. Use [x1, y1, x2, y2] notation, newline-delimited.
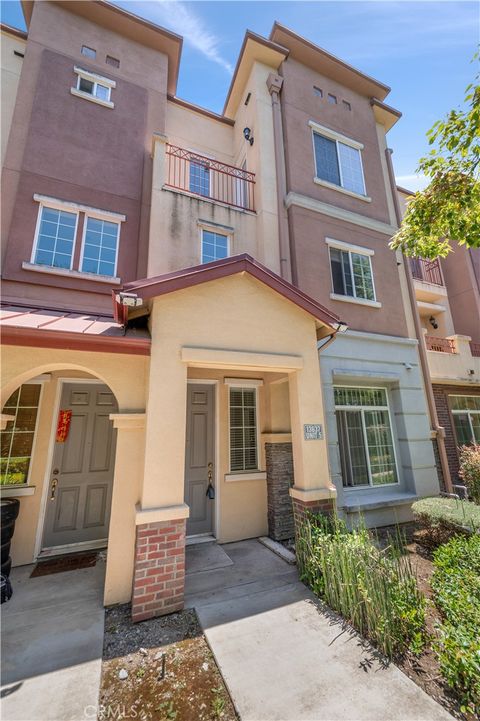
[432, 535, 480, 713]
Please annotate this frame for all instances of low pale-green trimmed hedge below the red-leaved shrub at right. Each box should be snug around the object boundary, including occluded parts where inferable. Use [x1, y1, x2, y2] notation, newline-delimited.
[412, 498, 480, 543]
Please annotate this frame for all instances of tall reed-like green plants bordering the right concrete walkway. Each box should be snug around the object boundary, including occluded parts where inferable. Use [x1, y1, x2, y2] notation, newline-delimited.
[297, 516, 425, 658]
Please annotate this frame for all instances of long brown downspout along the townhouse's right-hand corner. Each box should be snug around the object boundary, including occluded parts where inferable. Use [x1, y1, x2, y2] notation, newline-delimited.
[385, 148, 453, 493]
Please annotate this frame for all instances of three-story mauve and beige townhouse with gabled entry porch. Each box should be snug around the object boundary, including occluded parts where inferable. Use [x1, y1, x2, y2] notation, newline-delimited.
[1, 0, 439, 620]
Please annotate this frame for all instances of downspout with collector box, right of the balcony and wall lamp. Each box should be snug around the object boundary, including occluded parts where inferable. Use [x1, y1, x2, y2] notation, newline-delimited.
[267, 73, 292, 283]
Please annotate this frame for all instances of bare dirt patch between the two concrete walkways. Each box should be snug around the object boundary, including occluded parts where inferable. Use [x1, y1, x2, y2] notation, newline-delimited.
[98, 604, 238, 721]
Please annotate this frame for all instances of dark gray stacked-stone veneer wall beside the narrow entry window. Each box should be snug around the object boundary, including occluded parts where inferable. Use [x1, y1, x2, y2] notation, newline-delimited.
[265, 443, 295, 541]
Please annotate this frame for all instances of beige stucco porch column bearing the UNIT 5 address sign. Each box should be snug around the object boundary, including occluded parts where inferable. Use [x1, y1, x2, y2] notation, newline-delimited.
[289, 347, 336, 513]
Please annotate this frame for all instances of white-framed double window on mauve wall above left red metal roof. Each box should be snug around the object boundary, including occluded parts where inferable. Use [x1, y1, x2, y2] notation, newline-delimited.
[27, 195, 125, 282]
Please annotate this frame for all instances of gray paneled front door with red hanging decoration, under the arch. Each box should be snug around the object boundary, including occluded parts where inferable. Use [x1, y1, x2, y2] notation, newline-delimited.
[43, 383, 117, 548]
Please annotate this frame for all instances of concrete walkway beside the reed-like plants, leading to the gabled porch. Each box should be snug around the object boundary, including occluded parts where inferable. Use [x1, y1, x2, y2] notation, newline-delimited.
[186, 540, 452, 721]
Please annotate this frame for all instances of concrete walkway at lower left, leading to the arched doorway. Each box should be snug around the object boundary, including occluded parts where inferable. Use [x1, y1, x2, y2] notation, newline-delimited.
[2, 561, 105, 721]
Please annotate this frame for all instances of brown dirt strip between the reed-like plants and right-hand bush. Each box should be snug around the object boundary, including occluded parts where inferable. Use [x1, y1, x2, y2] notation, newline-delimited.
[372, 523, 473, 720]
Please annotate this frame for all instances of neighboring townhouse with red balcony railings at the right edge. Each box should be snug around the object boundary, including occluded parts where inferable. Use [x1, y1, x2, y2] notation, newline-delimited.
[398, 188, 480, 485]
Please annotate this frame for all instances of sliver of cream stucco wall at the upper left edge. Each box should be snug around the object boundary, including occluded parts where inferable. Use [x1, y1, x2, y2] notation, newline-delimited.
[0, 31, 26, 167]
